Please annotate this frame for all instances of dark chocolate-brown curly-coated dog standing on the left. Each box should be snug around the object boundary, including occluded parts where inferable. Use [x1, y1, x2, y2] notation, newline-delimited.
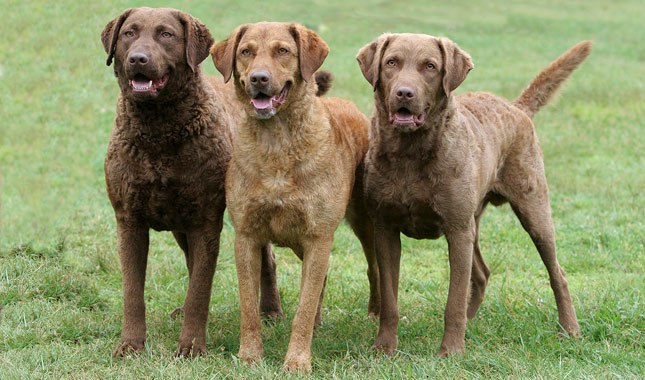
[101, 8, 282, 356]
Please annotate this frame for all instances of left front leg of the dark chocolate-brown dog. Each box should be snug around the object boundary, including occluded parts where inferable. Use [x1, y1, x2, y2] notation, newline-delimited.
[113, 220, 149, 356]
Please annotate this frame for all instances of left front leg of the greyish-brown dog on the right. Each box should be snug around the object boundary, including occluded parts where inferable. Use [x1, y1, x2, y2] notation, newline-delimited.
[374, 222, 401, 355]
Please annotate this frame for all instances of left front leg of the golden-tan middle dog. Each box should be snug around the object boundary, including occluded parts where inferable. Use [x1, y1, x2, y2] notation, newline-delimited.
[235, 232, 262, 363]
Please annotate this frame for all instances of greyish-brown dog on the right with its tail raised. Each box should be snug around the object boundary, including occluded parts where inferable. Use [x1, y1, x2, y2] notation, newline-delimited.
[357, 34, 591, 357]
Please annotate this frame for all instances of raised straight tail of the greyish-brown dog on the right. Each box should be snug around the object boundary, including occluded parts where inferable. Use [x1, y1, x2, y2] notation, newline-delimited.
[513, 41, 591, 117]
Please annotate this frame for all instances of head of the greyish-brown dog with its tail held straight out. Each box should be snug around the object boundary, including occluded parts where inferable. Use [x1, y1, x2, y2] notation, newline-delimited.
[356, 33, 473, 132]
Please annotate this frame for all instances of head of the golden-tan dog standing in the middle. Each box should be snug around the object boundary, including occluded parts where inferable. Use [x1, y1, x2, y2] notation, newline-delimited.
[211, 22, 329, 119]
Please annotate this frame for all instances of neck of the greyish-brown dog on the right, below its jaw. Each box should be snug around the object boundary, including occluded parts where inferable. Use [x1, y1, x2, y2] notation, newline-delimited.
[372, 93, 456, 161]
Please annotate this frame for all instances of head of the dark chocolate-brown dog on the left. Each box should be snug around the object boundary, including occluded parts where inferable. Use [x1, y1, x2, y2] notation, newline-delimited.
[101, 8, 214, 100]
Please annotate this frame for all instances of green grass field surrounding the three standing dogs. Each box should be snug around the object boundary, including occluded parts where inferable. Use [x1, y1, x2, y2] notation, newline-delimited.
[0, 0, 645, 379]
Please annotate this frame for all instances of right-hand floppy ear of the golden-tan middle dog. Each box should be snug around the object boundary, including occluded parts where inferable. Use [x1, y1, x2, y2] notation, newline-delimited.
[289, 24, 329, 82]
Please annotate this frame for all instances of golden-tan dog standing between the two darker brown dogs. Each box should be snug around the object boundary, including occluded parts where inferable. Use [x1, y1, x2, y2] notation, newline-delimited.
[211, 22, 379, 371]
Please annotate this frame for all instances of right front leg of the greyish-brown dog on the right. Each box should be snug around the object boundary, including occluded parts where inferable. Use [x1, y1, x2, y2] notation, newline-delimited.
[437, 221, 475, 357]
